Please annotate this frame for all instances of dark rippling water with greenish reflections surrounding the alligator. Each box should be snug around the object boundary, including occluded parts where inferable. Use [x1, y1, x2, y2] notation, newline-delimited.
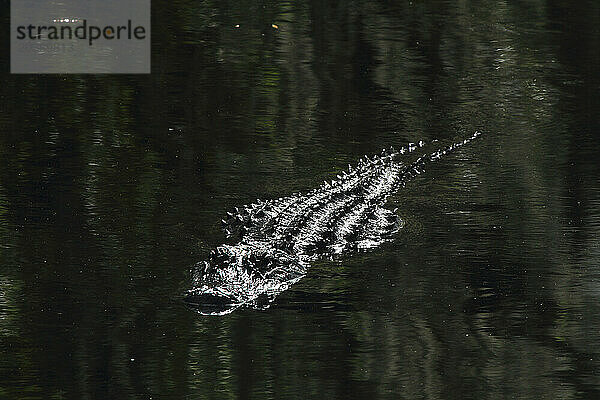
[0, 0, 600, 399]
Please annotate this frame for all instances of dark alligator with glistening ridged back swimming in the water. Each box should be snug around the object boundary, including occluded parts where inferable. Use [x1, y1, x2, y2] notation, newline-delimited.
[185, 132, 480, 315]
